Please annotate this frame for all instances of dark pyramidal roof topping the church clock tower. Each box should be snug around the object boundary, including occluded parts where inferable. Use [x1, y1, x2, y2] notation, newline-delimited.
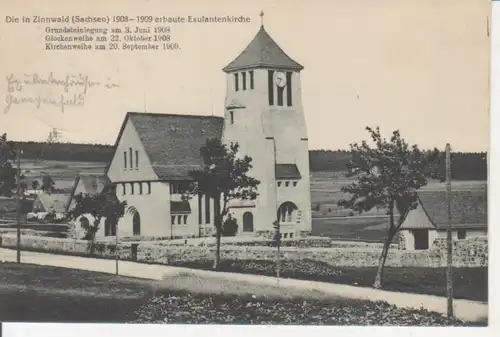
[223, 25, 304, 72]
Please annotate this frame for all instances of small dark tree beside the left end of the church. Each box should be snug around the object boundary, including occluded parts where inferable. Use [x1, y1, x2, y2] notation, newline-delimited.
[68, 188, 127, 255]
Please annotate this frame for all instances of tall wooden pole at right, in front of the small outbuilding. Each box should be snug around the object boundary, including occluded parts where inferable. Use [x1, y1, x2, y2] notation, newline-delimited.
[446, 143, 453, 318]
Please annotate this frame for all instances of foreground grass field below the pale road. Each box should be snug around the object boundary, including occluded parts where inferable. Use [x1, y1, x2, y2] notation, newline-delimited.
[0, 263, 478, 326]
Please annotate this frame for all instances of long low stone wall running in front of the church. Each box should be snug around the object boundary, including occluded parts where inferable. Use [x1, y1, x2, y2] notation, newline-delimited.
[0, 234, 488, 267]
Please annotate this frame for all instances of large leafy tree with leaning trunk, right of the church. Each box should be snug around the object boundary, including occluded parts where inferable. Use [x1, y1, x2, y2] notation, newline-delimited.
[338, 127, 443, 288]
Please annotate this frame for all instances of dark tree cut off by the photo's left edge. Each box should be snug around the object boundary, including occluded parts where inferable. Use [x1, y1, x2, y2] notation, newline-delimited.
[0, 133, 17, 197]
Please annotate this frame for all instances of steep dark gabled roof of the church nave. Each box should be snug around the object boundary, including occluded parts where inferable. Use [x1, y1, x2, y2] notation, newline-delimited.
[106, 112, 224, 181]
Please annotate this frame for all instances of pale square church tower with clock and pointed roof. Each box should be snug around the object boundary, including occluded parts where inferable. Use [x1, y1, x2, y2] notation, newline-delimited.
[223, 13, 311, 238]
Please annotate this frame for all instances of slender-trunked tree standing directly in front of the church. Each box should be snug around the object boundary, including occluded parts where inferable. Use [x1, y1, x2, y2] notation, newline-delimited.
[189, 138, 260, 269]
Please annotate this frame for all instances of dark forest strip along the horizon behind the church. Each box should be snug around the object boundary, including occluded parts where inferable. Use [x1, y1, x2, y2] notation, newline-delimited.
[12, 142, 488, 180]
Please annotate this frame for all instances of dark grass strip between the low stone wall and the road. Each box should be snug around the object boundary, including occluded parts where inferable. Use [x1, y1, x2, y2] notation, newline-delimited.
[169, 259, 488, 302]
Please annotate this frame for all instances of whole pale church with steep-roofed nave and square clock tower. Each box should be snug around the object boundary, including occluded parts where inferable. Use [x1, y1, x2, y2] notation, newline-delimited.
[106, 21, 311, 238]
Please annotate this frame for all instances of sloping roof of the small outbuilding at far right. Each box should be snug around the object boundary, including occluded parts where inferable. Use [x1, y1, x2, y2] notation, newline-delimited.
[418, 189, 488, 229]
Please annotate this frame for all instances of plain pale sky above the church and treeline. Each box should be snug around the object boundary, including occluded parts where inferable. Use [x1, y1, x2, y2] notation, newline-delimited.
[0, 0, 490, 151]
